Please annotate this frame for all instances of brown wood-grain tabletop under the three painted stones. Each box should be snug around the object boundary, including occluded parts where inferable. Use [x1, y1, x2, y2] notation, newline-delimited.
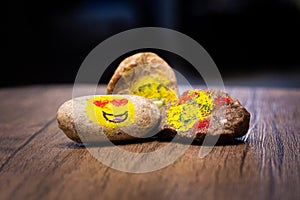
[0, 85, 300, 200]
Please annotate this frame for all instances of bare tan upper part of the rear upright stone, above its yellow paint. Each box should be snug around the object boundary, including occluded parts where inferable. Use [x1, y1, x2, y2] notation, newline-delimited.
[106, 52, 178, 95]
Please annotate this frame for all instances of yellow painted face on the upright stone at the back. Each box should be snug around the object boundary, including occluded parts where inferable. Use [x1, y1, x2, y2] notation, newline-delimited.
[131, 76, 177, 107]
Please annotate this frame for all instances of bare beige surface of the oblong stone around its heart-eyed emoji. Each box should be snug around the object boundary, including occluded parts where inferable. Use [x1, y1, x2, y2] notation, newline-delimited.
[57, 95, 161, 143]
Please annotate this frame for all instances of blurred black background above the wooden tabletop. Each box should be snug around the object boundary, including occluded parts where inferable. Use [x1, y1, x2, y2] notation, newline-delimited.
[4, 0, 300, 87]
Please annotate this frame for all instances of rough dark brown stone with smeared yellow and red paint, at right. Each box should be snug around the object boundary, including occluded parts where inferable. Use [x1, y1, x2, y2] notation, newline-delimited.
[160, 89, 250, 141]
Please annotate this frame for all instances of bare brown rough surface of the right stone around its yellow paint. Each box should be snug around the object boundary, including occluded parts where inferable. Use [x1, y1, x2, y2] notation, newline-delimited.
[160, 90, 250, 142]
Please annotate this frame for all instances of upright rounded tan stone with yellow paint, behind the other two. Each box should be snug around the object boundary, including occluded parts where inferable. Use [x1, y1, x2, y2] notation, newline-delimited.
[106, 52, 178, 107]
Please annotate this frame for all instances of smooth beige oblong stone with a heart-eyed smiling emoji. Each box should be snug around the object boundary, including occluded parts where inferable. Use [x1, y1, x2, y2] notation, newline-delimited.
[57, 95, 161, 142]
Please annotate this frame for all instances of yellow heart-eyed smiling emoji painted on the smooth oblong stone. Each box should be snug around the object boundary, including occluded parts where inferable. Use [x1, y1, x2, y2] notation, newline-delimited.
[86, 96, 135, 128]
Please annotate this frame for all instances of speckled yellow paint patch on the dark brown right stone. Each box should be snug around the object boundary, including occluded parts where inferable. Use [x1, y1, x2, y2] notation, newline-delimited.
[166, 90, 213, 132]
